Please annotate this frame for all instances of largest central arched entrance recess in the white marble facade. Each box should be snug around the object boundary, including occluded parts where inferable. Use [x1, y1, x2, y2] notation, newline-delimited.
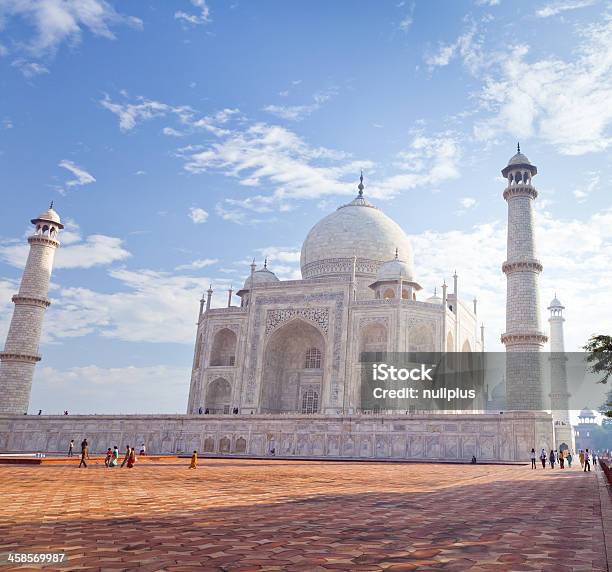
[260, 319, 325, 413]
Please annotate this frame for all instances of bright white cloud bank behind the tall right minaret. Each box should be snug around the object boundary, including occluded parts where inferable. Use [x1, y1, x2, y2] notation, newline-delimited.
[411, 203, 612, 351]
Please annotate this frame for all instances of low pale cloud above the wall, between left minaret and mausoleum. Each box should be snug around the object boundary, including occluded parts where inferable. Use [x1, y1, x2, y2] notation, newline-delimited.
[30, 365, 191, 414]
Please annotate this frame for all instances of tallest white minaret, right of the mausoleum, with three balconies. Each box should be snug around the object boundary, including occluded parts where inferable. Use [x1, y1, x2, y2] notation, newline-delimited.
[501, 146, 548, 410]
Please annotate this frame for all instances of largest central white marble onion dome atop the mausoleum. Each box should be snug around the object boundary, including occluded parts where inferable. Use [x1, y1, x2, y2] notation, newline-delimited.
[300, 192, 413, 278]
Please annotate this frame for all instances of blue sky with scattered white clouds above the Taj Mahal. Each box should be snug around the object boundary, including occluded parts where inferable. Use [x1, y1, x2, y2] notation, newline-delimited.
[0, 0, 612, 412]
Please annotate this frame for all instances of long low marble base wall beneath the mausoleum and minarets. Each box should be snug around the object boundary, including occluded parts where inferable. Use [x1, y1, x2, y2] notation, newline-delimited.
[0, 411, 554, 461]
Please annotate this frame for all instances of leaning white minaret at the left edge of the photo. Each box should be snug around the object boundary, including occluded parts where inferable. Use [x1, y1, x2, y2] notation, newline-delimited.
[0, 203, 64, 414]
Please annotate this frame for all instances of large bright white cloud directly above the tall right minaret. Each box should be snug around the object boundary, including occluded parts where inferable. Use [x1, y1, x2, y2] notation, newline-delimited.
[474, 12, 612, 155]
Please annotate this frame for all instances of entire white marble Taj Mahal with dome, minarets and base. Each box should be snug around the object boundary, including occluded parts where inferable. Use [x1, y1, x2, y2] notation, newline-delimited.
[0, 148, 573, 461]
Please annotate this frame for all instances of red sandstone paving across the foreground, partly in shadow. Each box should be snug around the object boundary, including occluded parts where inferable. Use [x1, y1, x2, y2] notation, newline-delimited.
[0, 459, 607, 572]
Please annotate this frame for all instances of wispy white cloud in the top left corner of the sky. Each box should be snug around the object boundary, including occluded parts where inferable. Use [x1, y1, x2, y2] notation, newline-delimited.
[0, 0, 142, 56]
